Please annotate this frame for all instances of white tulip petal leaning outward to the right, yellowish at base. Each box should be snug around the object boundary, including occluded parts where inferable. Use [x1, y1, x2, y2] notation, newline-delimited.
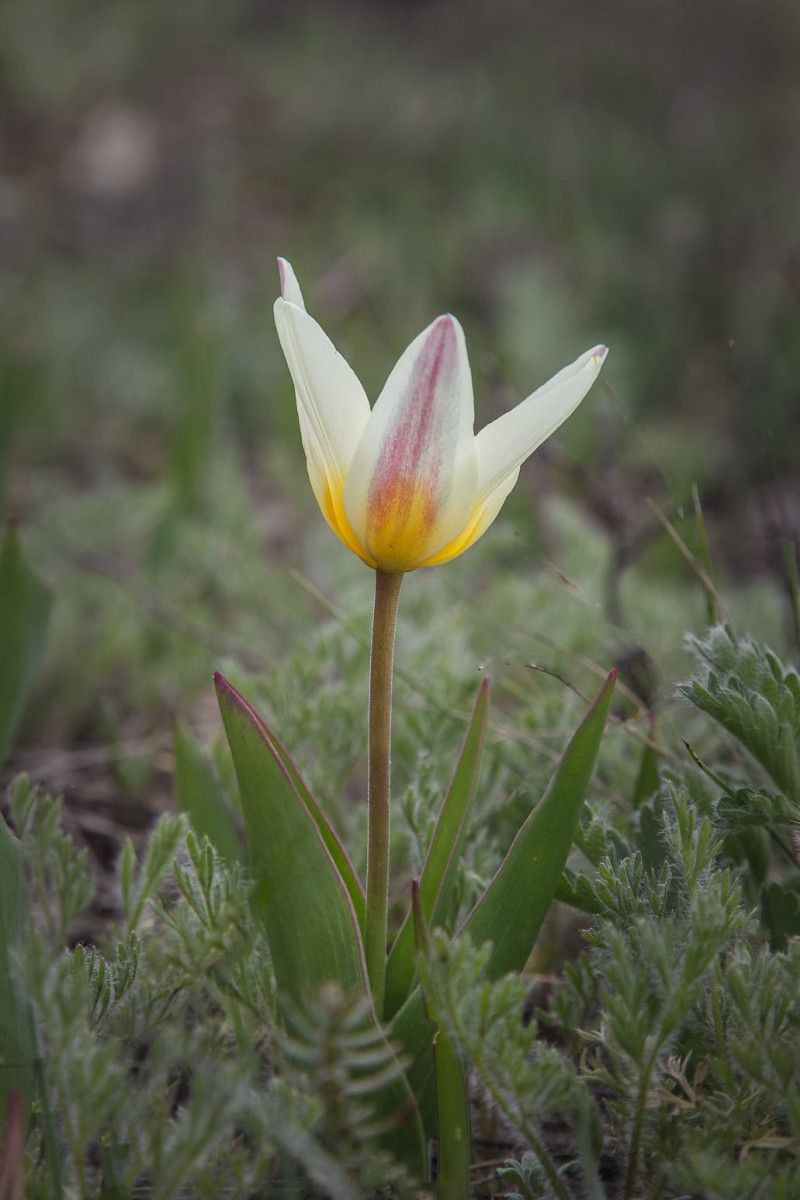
[475, 346, 608, 504]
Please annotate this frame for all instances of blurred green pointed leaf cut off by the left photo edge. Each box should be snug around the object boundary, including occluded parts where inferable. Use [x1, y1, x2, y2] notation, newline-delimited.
[0, 527, 53, 764]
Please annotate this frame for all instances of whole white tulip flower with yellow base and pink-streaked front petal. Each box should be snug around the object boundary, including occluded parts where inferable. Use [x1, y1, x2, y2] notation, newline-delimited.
[275, 259, 607, 574]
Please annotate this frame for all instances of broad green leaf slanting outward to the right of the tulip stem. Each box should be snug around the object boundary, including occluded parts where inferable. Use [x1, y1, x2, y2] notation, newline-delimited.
[462, 671, 616, 979]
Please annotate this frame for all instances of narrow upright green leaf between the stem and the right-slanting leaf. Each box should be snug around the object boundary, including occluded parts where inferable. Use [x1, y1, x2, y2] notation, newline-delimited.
[384, 679, 489, 1016]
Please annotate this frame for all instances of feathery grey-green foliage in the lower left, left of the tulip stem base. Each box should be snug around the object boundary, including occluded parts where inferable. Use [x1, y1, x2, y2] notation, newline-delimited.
[14, 785, 431, 1200]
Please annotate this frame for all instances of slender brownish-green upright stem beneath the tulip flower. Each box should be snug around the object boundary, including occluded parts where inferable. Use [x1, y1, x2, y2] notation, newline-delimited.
[365, 569, 403, 1018]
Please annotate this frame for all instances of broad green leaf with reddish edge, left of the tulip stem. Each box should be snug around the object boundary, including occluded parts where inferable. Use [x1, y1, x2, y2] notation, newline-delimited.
[215, 674, 368, 1000]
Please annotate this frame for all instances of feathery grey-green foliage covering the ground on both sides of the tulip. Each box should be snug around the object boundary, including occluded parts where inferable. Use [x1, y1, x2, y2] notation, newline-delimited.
[6, 626, 800, 1200]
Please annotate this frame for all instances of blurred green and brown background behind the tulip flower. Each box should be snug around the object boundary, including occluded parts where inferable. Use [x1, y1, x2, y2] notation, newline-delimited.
[0, 0, 800, 782]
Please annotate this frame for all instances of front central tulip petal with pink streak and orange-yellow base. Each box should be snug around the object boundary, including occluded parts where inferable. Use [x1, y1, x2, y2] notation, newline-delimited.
[344, 317, 477, 570]
